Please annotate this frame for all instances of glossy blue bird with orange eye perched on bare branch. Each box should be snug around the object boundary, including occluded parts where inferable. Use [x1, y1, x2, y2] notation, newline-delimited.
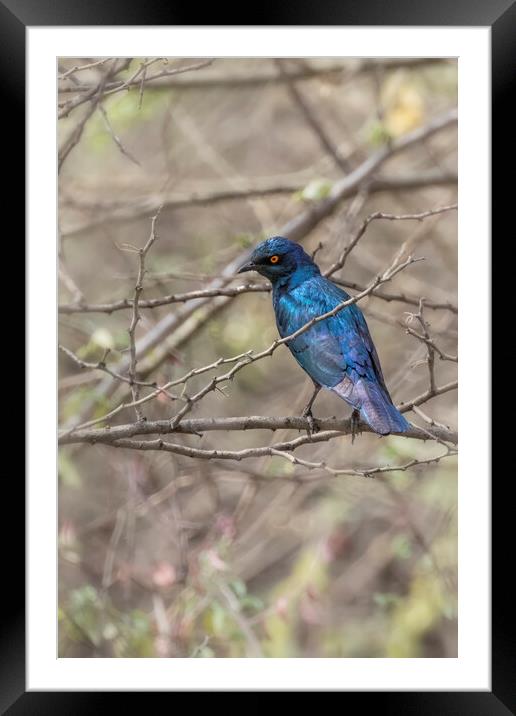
[238, 236, 410, 435]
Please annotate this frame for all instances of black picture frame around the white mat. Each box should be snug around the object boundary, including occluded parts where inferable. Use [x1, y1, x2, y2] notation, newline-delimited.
[10, 0, 510, 716]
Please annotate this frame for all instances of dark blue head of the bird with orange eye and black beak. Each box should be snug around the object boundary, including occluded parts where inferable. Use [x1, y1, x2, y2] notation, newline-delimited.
[237, 236, 320, 284]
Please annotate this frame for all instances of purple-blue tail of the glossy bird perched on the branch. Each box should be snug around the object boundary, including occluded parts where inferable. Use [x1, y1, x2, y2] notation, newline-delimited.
[333, 380, 410, 435]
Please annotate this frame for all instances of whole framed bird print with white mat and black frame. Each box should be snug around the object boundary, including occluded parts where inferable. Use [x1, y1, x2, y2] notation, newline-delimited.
[8, 3, 508, 714]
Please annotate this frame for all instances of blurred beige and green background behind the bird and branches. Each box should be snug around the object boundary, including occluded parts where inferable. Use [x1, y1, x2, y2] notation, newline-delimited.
[59, 58, 457, 657]
